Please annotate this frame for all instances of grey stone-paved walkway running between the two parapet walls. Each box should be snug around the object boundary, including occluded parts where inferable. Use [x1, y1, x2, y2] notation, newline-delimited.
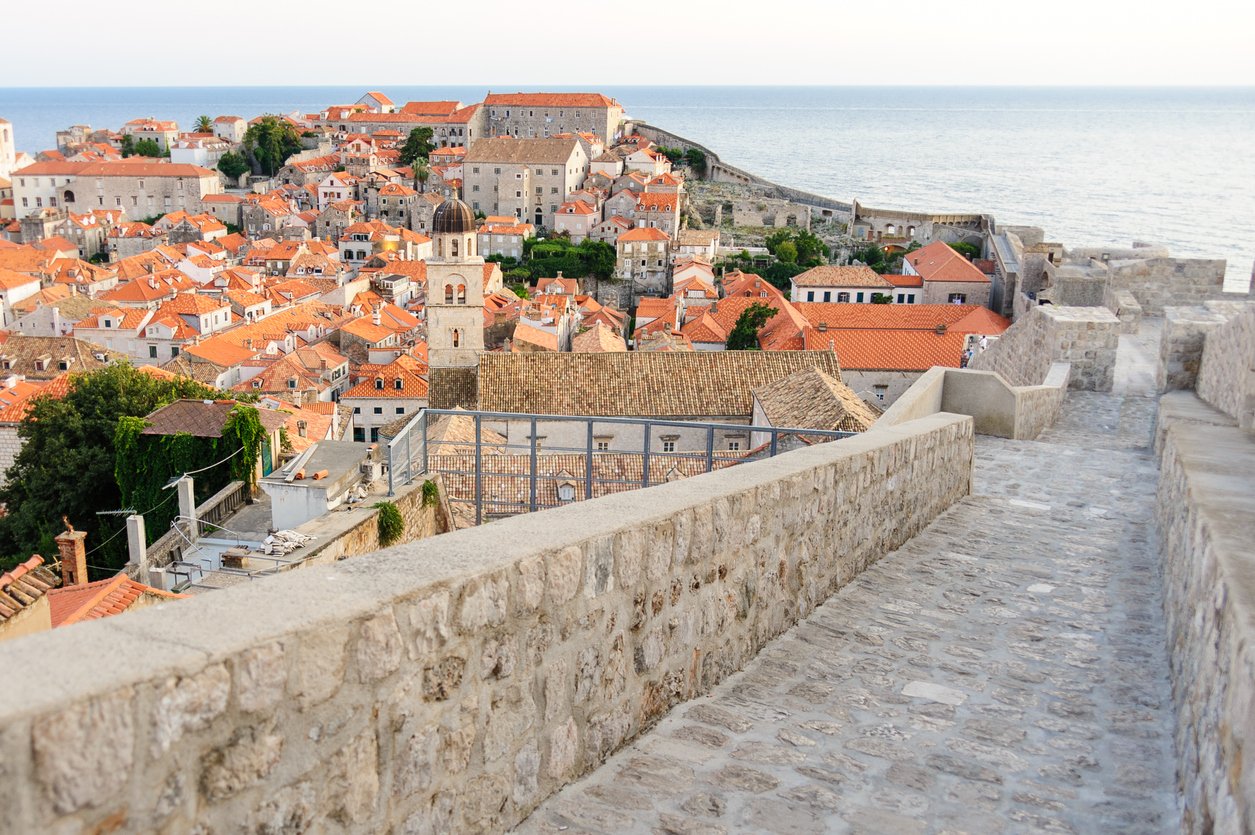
[518, 381, 1180, 834]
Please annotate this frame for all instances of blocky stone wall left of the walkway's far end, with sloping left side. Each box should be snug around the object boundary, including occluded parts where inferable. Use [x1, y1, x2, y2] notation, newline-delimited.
[968, 305, 1119, 392]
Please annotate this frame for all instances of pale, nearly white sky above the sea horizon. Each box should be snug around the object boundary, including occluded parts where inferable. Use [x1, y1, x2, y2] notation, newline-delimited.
[7, 0, 1255, 89]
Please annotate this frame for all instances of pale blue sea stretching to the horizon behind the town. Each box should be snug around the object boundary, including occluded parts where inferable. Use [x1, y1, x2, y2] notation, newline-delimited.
[0, 84, 1255, 290]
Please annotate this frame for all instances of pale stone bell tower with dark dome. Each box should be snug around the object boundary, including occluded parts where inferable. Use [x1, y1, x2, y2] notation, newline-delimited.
[427, 193, 483, 408]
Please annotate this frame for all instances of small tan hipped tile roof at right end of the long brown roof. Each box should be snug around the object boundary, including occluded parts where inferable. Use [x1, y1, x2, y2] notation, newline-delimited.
[754, 368, 880, 432]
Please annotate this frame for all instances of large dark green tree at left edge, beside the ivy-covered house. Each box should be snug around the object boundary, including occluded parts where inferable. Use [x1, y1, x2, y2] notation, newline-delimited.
[0, 364, 217, 566]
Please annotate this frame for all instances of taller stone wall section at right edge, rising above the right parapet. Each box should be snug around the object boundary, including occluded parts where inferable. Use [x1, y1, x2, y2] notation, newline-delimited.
[1199, 303, 1255, 429]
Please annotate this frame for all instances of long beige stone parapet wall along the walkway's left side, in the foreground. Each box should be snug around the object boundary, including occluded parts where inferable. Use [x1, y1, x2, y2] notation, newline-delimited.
[0, 416, 973, 832]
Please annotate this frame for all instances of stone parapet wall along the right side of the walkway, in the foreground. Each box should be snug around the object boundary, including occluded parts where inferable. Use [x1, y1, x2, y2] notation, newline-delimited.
[1158, 392, 1255, 832]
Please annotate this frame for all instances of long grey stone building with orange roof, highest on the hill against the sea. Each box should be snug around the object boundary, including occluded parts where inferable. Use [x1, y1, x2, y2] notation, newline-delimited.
[483, 93, 624, 143]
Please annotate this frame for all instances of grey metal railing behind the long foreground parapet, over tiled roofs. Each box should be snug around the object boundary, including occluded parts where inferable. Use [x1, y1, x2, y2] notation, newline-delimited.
[385, 409, 855, 525]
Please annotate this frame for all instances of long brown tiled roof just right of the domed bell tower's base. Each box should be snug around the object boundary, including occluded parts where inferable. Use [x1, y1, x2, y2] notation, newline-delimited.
[479, 350, 841, 418]
